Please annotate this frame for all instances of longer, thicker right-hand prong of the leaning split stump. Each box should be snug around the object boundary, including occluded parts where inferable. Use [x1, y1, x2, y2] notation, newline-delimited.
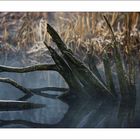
[45, 24, 111, 96]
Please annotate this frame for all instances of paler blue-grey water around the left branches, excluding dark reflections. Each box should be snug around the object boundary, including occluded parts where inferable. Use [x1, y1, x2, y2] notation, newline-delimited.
[0, 55, 68, 127]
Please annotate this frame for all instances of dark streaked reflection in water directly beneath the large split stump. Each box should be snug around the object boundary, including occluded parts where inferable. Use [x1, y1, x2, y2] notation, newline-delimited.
[57, 98, 116, 128]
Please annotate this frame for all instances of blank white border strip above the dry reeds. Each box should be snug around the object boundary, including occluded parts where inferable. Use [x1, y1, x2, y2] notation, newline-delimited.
[0, 0, 140, 12]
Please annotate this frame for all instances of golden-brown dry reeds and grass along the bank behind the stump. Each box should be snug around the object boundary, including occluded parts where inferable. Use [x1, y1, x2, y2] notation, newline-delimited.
[0, 12, 140, 65]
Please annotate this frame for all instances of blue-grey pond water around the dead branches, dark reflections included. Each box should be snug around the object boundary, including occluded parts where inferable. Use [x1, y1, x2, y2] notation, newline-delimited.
[0, 55, 140, 128]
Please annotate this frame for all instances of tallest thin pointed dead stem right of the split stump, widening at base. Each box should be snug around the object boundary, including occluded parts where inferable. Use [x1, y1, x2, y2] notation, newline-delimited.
[104, 16, 136, 100]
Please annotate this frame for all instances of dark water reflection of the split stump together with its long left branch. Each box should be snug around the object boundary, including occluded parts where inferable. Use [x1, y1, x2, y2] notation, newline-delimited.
[0, 93, 118, 128]
